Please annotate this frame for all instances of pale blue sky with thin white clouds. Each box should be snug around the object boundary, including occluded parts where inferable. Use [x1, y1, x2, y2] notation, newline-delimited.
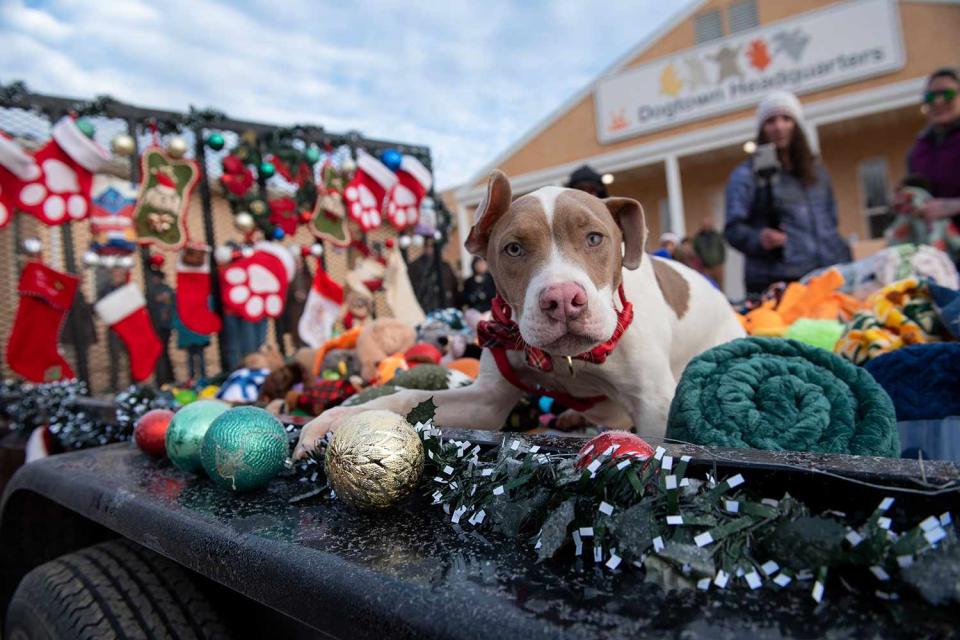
[0, 0, 690, 190]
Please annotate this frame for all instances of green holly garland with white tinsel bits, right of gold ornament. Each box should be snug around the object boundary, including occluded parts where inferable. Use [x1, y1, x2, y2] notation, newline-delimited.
[294, 400, 960, 605]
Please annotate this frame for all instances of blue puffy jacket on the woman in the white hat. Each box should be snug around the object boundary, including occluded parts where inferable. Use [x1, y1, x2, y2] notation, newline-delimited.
[724, 160, 850, 288]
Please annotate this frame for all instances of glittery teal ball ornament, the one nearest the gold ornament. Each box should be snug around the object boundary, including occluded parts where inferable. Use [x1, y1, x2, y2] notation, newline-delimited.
[200, 407, 289, 491]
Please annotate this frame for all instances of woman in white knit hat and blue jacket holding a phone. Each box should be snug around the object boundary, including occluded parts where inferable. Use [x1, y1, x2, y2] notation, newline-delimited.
[724, 91, 850, 295]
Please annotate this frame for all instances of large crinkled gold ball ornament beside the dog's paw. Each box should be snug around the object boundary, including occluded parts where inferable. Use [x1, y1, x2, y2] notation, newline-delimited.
[325, 410, 424, 510]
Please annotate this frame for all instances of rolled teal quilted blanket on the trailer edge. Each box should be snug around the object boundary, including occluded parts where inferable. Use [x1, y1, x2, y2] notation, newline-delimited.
[667, 338, 900, 457]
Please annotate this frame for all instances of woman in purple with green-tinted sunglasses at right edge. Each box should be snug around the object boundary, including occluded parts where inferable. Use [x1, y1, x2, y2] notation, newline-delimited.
[907, 69, 960, 248]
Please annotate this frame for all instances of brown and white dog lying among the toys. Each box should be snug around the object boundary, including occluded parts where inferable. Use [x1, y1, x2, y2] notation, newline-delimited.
[294, 171, 744, 457]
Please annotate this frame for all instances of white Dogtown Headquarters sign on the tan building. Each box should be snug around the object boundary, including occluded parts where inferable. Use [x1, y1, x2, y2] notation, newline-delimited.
[594, 0, 904, 143]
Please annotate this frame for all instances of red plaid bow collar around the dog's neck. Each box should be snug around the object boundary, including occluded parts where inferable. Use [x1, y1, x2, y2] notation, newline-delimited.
[477, 283, 633, 371]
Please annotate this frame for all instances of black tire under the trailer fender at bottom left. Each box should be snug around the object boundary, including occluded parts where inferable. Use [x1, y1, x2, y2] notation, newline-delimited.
[4, 540, 229, 640]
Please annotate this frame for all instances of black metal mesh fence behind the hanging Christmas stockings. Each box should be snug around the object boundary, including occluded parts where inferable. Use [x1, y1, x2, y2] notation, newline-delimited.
[0, 83, 451, 394]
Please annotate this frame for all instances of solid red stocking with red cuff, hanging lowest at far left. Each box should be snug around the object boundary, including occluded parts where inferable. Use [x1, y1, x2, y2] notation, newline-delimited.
[7, 262, 79, 382]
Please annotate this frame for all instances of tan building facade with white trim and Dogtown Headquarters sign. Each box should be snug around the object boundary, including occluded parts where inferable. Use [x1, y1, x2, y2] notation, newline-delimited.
[448, 0, 960, 298]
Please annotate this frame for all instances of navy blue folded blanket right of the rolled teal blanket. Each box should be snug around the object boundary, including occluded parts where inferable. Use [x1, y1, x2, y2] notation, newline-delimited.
[864, 342, 960, 420]
